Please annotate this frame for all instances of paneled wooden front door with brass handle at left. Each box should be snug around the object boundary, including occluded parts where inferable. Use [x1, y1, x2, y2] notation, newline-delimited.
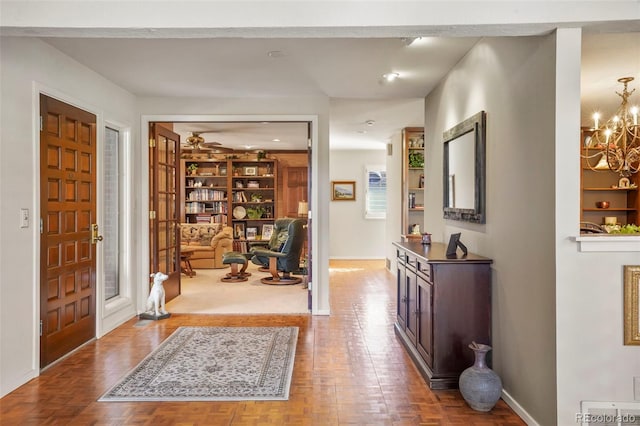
[40, 95, 97, 368]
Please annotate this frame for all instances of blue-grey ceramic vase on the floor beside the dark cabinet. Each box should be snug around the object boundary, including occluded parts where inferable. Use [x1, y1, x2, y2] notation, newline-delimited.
[458, 342, 502, 412]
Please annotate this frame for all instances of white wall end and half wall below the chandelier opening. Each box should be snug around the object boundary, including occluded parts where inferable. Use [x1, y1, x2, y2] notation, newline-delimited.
[555, 29, 640, 425]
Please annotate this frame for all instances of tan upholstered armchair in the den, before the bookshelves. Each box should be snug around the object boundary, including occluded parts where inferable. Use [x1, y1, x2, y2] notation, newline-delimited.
[180, 223, 233, 269]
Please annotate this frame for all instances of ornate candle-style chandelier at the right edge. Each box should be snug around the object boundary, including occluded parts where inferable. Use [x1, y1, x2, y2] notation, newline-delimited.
[582, 77, 640, 177]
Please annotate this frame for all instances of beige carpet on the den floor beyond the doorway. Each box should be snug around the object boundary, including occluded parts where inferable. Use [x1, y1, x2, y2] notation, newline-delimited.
[167, 263, 309, 314]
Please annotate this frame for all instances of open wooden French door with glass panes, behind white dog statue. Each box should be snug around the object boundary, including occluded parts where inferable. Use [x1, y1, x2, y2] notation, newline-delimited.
[149, 123, 180, 302]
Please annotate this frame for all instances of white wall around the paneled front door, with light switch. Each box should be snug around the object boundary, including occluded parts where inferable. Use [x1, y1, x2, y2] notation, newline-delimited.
[0, 37, 135, 396]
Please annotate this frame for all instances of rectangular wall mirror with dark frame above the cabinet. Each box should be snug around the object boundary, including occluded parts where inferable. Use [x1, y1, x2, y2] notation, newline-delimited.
[442, 111, 486, 223]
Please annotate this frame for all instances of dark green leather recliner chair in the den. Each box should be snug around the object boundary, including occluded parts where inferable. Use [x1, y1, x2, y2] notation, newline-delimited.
[251, 218, 305, 285]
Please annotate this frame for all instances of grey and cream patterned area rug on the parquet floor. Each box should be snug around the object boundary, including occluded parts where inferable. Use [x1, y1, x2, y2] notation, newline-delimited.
[98, 327, 298, 401]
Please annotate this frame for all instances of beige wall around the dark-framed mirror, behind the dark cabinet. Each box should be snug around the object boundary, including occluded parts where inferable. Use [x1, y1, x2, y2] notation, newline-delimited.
[425, 36, 560, 425]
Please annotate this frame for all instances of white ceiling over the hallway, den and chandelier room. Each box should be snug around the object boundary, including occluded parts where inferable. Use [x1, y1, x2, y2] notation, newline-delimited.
[43, 33, 640, 150]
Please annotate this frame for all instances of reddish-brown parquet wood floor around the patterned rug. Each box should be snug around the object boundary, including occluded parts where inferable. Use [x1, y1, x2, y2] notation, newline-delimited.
[0, 261, 525, 426]
